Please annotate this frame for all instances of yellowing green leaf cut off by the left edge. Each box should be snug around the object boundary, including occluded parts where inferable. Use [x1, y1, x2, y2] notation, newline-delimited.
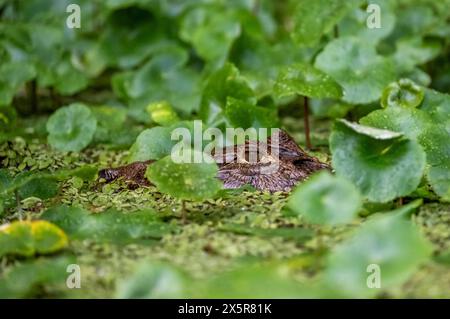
[0, 220, 68, 257]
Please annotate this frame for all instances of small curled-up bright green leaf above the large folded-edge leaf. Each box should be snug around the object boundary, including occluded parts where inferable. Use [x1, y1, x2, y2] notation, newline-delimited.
[381, 79, 425, 108]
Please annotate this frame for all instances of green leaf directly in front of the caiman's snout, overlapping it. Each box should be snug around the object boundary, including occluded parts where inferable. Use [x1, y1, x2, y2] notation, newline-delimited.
[145, 150, 222, 201]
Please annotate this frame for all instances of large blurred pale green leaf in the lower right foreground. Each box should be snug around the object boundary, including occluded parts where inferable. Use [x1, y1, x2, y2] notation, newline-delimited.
[324, 215, 431, 298]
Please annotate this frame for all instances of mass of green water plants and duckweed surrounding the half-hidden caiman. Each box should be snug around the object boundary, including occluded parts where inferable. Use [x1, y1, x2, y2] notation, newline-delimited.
[0, 0, 450, 298]
